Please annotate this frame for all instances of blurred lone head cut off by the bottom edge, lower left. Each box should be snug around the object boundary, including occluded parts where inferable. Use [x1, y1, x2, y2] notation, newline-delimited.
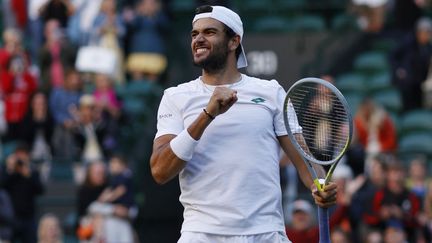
[38, 213, 63, 243]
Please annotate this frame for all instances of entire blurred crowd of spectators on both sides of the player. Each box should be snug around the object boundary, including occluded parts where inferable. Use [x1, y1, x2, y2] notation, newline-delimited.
[0, 0, 432, 243]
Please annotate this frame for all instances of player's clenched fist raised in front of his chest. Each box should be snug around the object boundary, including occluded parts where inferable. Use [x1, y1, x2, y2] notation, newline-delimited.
[206, 87, 237, 116]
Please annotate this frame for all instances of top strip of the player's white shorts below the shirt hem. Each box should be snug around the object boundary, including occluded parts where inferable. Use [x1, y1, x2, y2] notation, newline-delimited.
[177, 231, 291, 243]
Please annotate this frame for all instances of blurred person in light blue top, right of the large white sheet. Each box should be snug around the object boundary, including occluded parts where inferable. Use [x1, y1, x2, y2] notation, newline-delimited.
[93, 0, 126, 84]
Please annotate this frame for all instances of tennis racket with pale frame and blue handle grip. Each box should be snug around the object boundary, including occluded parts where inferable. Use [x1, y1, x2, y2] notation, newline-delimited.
[284, 78, 353, 243]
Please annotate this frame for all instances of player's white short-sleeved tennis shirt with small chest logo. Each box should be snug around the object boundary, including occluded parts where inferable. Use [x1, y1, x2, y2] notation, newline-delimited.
[156, 74, 301, 235]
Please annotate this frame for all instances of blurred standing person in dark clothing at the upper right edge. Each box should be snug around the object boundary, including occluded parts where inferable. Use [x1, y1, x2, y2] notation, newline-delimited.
[390, 17, 432, 111]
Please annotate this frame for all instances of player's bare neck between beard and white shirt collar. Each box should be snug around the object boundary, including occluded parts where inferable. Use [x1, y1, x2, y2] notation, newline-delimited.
[202, 67, 241, 85]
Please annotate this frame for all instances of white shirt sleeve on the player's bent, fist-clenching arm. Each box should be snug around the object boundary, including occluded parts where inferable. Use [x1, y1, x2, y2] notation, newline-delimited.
[155, 92, 184, 138]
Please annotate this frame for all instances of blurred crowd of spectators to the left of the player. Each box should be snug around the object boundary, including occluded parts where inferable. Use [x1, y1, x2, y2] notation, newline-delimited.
[0, 0, 170, 243]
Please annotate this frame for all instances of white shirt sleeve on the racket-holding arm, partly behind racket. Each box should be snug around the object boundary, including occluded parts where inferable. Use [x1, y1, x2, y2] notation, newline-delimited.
[274, 86, 302, 136]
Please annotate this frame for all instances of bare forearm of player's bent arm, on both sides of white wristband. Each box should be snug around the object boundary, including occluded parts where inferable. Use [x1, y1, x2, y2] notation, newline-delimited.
[150, 112, 212, 184]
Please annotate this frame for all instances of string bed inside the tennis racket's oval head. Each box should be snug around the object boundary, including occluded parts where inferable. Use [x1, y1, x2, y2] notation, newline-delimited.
[288, 84, 349, 161]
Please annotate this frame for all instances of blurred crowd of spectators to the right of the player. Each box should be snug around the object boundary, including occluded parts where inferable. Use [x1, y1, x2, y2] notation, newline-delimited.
[281, 0, 432, 243]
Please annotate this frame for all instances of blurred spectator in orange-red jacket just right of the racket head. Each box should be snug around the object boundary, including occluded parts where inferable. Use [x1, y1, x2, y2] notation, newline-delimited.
[354, 98, 397, 164]
